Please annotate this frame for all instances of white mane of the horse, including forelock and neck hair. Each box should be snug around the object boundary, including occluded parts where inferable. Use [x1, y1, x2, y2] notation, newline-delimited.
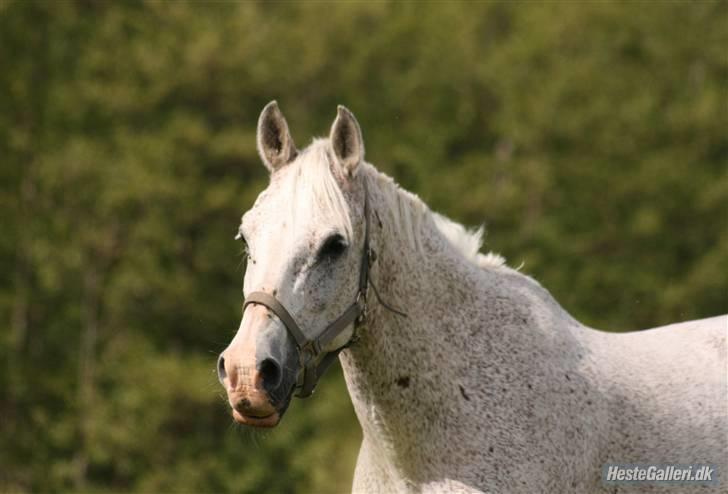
[290, 139, 505, 269]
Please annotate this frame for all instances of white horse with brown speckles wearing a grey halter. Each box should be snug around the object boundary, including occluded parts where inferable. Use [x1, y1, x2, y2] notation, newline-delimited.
[218, 102, 728, 493]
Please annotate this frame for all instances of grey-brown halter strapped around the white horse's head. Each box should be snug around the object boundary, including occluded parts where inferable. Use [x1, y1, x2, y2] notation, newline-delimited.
[243, 188, 378, 398]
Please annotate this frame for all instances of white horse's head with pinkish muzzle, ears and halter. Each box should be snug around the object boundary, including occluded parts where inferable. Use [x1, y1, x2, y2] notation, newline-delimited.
[217, 101, 369, 427]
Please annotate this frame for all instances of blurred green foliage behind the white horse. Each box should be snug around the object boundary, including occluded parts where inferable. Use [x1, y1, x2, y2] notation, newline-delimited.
[0, 0, 728, 493]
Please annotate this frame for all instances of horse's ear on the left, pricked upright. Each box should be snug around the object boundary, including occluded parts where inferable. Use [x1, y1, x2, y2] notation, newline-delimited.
[257, 100, 298, 173]
